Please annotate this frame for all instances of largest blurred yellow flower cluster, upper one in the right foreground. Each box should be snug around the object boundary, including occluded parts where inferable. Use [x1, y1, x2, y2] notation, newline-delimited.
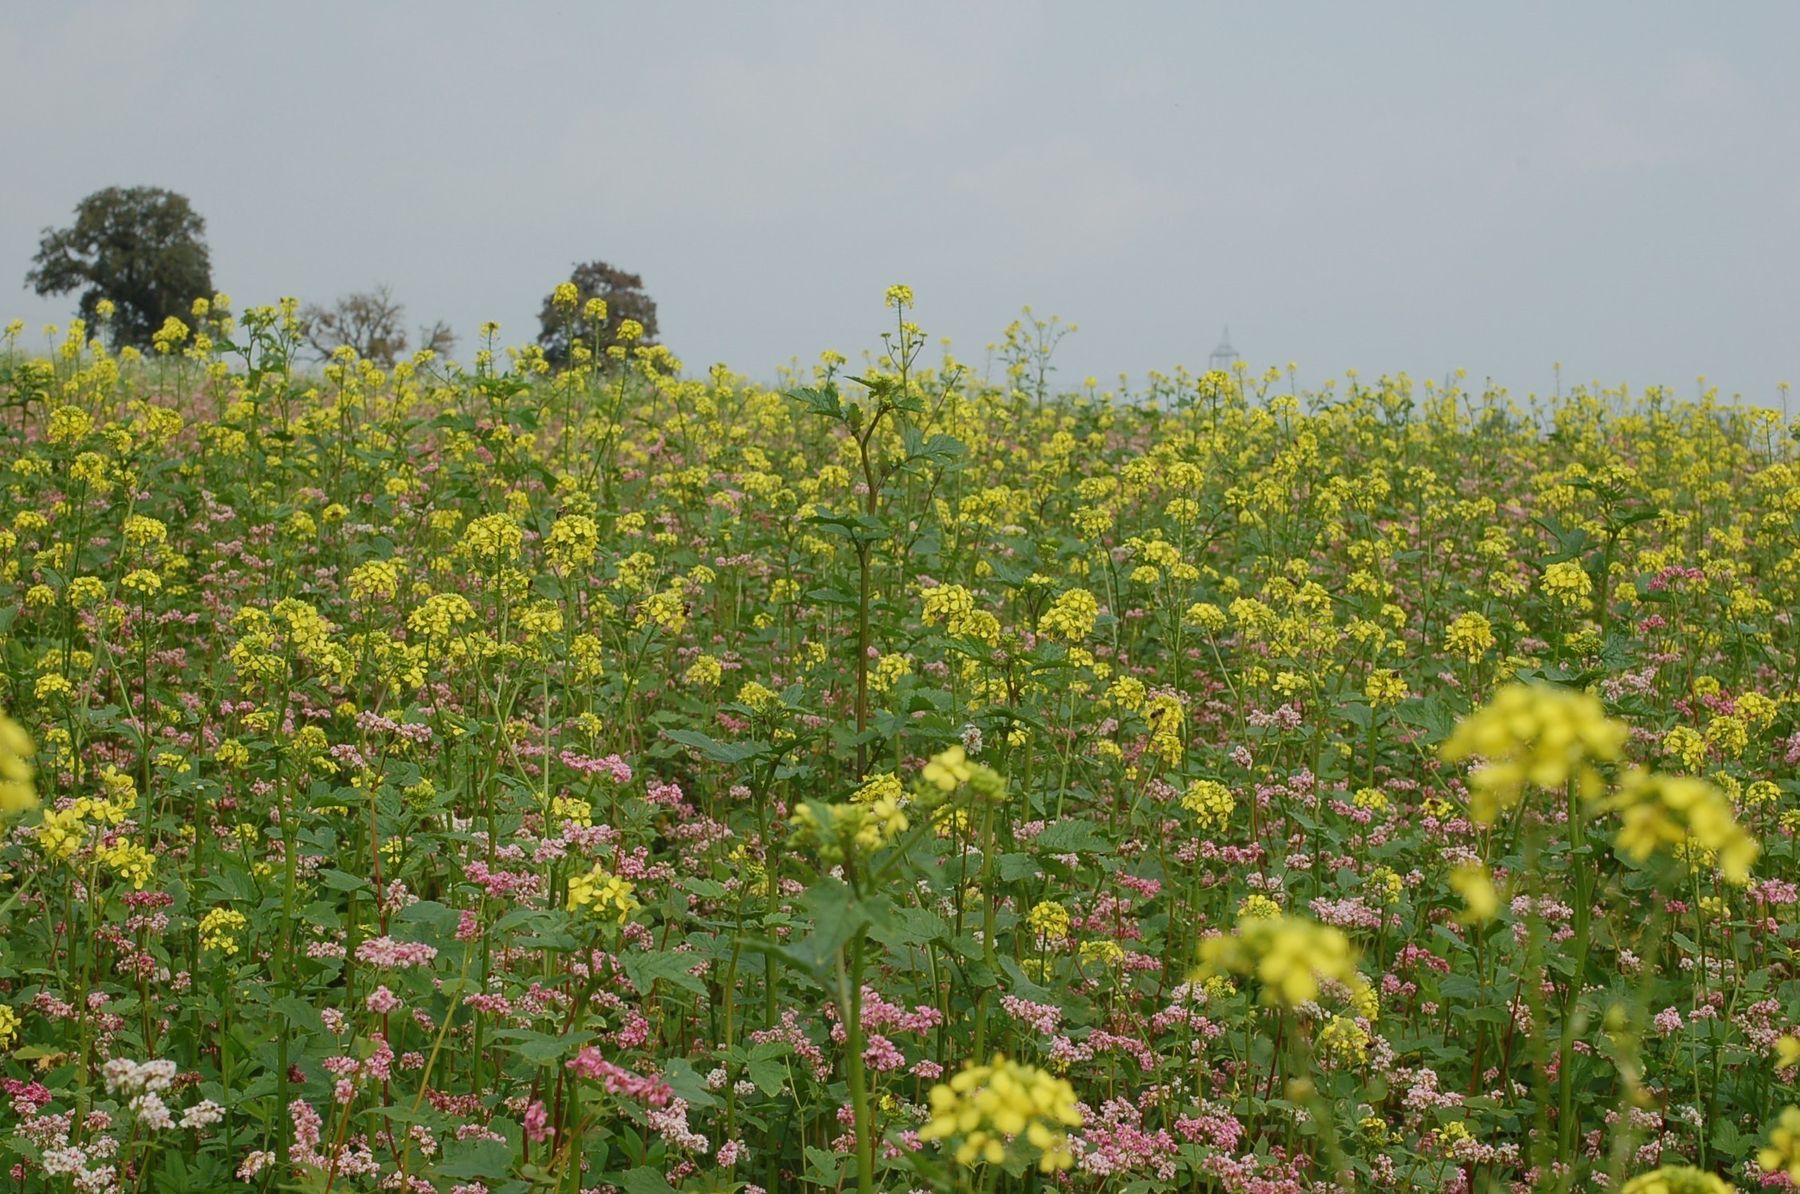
[1442, 684, 1627, 825]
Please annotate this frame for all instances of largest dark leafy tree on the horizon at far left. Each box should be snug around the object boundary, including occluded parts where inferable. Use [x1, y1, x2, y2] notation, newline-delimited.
[25, 187, 212, 346]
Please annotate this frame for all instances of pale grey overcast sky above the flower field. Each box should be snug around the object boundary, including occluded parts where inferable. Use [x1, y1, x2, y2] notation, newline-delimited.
[0, 0, 1800, 402]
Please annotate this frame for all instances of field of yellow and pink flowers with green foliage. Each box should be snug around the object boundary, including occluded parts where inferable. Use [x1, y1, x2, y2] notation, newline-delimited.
[0, 286, 1800, 1194]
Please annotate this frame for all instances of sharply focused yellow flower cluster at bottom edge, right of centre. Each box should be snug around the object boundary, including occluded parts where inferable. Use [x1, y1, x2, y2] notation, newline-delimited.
[918, 1054, 1082, 1172]
